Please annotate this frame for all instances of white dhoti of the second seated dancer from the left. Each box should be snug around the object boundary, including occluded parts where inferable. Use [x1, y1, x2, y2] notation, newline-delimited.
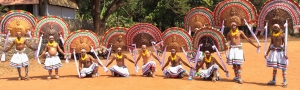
[110, 65, 129, 77]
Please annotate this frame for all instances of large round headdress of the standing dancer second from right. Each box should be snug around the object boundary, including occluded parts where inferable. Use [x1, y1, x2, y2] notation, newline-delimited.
[214, 0, 257, 27]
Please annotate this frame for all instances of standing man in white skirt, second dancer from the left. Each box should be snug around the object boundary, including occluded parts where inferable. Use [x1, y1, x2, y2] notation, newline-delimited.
[38, 35, 65, 80]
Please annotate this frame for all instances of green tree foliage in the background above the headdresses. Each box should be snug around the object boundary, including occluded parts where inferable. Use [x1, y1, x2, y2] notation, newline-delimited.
[77, 0, 300, 36]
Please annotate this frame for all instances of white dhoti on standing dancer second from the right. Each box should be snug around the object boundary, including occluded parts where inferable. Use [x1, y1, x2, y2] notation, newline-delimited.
[226, 45, 244, 65]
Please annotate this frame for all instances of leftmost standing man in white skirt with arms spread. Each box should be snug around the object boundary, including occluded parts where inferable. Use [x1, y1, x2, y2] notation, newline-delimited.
[3, 32, 36, 80]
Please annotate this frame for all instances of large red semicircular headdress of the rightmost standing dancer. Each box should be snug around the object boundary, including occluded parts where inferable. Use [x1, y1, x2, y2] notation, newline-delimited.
[256, 0, 300, 33]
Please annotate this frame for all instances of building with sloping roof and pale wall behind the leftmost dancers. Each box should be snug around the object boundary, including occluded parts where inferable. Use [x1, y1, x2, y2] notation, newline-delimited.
[0, 0, 78, 19]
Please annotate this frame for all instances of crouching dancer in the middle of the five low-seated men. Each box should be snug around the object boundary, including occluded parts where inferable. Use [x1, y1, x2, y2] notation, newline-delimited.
[135, 45, 161, 78]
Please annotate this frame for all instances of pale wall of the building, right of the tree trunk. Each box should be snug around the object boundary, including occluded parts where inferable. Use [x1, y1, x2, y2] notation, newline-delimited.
[48, 5, 76, 19]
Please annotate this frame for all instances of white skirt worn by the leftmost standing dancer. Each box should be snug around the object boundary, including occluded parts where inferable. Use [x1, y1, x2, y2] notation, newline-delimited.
[9, 48, 29, 68]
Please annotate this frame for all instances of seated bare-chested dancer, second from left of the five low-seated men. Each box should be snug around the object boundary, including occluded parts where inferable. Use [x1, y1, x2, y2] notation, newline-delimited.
[106, 47, 134, 77]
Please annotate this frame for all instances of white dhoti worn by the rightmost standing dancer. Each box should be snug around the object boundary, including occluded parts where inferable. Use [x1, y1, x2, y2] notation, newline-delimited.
[267, 45, 288, 69]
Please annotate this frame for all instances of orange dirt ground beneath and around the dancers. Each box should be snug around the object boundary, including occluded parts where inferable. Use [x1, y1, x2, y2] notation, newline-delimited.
[0, 41, 300, 90]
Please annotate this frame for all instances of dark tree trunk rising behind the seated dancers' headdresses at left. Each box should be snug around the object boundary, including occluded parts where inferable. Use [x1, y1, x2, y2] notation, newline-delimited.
[91, 0, 104, 35]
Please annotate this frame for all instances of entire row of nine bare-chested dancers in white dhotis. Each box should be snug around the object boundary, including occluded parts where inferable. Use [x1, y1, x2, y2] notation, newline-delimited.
[3, 22, 288, 87]
